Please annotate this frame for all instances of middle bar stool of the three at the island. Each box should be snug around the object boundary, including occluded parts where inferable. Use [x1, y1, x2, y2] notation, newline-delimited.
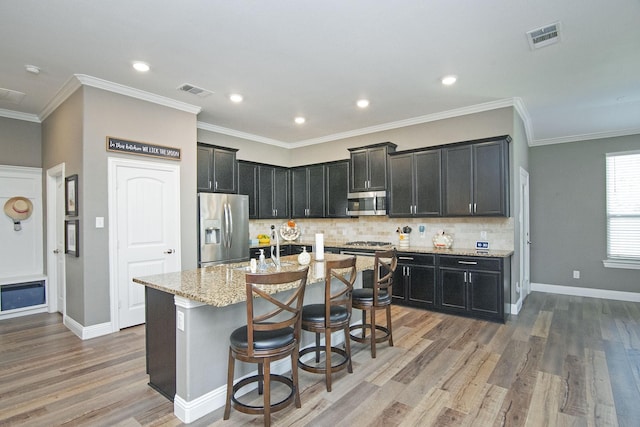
[298, 257, 358, 391]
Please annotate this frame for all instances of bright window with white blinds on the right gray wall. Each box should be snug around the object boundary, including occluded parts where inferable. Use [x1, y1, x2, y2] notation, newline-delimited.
[605, 151, 640, 268]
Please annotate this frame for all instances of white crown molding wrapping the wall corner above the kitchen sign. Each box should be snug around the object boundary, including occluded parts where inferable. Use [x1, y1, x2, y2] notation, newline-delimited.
[40, 74, 202, 121]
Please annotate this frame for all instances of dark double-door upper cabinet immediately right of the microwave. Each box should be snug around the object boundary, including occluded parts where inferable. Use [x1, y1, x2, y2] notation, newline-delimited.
[387, 149, 442, 217]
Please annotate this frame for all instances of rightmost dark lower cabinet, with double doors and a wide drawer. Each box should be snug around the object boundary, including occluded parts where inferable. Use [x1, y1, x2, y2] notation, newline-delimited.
[437, 255, 511, 321]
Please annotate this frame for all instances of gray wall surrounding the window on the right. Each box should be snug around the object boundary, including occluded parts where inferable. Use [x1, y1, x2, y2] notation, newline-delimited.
[529, 135, 640, 292]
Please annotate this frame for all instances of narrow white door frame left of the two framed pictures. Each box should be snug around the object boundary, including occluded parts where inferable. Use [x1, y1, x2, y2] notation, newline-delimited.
[46, 163, 67, 319]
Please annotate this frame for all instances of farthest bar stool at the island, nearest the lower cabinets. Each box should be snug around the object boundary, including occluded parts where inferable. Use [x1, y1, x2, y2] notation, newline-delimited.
[349, 249, 398, 358]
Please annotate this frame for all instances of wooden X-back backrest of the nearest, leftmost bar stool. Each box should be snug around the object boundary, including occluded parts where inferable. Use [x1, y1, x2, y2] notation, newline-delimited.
[246, 266, 309, 356]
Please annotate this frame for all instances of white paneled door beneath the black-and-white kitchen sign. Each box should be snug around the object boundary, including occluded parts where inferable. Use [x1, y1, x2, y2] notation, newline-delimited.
[109, 159, 181, 329]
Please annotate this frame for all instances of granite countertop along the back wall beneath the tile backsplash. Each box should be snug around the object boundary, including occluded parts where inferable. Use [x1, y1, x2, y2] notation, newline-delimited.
[251, 239, 513, 258]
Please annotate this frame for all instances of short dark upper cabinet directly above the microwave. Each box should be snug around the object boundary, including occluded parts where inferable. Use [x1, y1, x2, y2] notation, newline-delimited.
[349, 142, 397, 193]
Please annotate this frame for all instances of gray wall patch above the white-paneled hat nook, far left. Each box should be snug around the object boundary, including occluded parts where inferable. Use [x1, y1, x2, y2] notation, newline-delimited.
[0, 117, 42, 168]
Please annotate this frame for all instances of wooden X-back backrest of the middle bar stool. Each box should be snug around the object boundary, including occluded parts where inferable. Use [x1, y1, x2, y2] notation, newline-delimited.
[324, 256, 358, 323]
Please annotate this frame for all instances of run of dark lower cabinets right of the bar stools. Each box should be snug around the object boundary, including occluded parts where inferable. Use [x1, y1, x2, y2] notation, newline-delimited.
[392, 252, 511, 322]
